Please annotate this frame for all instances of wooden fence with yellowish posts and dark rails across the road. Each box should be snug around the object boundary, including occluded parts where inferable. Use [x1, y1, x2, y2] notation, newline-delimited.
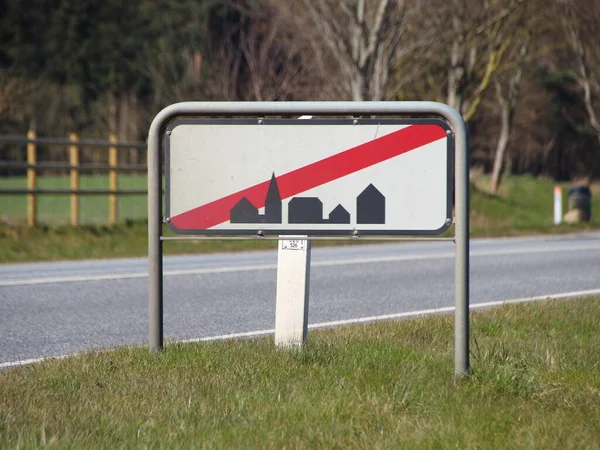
[0, 131, 148, 227]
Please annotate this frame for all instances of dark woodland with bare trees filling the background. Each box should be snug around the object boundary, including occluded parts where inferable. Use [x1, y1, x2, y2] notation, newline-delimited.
[0, 0, 600, 183]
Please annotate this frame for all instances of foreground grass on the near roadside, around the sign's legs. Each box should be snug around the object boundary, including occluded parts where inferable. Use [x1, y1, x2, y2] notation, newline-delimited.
[0, 297, 600, 449]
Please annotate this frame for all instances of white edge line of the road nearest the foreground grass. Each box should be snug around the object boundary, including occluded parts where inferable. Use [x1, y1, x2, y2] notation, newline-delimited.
[0, 288, 600, 370]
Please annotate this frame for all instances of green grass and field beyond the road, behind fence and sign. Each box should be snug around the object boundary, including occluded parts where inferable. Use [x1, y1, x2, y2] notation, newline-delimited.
[0, 175, 600, 262]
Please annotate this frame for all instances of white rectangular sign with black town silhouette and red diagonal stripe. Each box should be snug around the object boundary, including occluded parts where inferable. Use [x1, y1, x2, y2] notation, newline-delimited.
[165, 118, 453, 235]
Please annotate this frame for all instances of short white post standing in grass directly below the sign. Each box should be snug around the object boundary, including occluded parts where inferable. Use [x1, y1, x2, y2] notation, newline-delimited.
[275, 236, 311, 348]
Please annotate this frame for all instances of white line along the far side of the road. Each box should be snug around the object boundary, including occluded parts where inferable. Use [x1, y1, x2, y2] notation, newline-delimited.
[0, 245, 600, 287]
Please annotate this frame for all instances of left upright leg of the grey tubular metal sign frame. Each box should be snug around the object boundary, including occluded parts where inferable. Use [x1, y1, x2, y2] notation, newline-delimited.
[148, 114, 163, 351]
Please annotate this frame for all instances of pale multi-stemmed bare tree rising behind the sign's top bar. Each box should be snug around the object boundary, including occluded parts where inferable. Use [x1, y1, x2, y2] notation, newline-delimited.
[272, 0, 425, 101]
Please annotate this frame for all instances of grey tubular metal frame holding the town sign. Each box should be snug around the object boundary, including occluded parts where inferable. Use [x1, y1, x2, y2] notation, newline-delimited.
[148, 102, 470, 377]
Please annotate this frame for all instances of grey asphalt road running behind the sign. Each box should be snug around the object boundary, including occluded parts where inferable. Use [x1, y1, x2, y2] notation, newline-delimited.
[0, 232, 600, 366]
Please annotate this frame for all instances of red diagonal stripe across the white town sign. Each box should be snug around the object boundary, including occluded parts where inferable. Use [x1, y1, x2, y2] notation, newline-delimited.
[171, 124, 446, 230]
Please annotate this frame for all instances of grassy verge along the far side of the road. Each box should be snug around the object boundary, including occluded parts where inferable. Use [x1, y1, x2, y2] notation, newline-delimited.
[0, 176, 600, 262]
